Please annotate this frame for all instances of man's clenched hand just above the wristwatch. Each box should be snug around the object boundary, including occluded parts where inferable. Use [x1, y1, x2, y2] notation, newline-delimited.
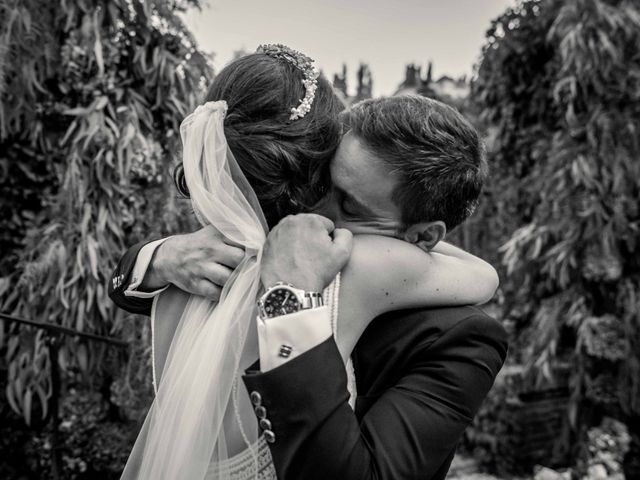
[261, 214, 352, 292]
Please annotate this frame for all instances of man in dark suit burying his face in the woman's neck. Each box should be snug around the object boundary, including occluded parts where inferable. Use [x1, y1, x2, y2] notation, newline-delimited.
[110, 98, 506, 480]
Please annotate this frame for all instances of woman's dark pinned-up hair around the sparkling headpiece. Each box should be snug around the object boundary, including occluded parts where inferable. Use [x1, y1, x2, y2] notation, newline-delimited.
[174, 53, 344, 227]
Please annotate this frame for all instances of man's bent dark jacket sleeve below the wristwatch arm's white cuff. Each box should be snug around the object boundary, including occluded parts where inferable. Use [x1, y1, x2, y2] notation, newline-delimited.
[244, 314, 507, 480]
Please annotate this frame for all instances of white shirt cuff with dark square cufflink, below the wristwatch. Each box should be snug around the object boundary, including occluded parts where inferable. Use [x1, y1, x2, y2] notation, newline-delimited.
[258, 306, 333, 372]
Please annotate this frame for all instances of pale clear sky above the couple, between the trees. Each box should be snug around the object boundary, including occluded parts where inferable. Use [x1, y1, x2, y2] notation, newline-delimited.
[180, 0, 514, 96]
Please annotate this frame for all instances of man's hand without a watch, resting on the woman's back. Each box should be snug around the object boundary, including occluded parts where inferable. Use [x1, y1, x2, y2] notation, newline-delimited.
[139, 225, 244, 300]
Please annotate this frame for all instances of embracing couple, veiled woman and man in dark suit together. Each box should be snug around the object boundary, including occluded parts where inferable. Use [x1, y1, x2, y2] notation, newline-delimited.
[109, 45, 507, 480]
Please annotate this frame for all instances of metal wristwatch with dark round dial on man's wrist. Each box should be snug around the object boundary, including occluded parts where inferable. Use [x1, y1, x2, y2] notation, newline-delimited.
[258, 282, 324, 319]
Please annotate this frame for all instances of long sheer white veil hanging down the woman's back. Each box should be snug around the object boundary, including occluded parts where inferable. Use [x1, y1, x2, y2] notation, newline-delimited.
[122, 101, 267, 480]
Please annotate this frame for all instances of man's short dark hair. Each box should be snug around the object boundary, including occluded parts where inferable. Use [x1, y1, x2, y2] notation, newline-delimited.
[343, 95, 487, 230]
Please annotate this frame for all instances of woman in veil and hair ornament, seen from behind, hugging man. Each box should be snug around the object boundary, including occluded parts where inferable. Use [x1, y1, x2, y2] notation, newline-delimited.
[122, 45, 496, 480]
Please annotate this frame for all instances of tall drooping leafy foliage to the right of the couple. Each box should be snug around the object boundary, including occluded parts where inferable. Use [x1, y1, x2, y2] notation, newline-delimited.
[472, 0, 640, 454]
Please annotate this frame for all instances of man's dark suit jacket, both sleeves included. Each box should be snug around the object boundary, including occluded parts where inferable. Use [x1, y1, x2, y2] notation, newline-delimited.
[110, 244, 507, 480]
